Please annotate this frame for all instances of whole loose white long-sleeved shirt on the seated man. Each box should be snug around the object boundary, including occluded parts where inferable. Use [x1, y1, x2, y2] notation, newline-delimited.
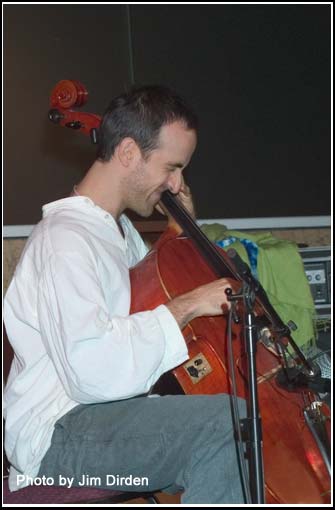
[4, 196, 188, 490]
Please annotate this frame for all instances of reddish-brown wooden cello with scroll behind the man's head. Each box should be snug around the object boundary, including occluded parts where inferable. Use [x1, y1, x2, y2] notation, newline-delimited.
[49, 80, 331, 504]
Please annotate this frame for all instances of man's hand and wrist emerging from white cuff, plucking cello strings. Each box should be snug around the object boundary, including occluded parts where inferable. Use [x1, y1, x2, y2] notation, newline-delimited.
[166, 278, 232, 329]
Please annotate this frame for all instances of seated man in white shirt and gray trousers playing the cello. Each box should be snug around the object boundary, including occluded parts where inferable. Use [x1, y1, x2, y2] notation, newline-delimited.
[4, 86, 244, 504]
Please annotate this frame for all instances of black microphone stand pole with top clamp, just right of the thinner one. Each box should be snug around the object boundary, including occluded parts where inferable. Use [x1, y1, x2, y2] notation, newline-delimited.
[227, 280, 265, 504]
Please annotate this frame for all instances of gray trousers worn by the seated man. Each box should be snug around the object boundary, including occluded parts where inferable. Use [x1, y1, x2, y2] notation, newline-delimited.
[38, 394, 245, 504]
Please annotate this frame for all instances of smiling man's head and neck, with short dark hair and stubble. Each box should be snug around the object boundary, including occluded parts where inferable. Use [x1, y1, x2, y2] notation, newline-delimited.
[89, 86, 197, 217]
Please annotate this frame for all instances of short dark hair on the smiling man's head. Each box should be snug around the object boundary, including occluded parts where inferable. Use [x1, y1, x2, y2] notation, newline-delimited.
[97, 85, 198, 161]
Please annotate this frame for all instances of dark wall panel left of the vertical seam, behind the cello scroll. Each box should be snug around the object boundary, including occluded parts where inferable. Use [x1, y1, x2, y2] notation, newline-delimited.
[4, 5, 130, 225]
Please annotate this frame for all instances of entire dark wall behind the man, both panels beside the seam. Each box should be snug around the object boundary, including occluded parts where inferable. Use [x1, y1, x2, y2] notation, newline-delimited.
[4, 4, 330, 225]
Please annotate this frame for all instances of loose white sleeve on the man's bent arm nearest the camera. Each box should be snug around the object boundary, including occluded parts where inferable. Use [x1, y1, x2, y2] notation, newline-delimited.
[38, 252, 188, 404]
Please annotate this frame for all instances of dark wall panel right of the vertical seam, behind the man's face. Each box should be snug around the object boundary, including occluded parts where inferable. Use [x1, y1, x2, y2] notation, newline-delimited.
[130, 5, 330, 218]
